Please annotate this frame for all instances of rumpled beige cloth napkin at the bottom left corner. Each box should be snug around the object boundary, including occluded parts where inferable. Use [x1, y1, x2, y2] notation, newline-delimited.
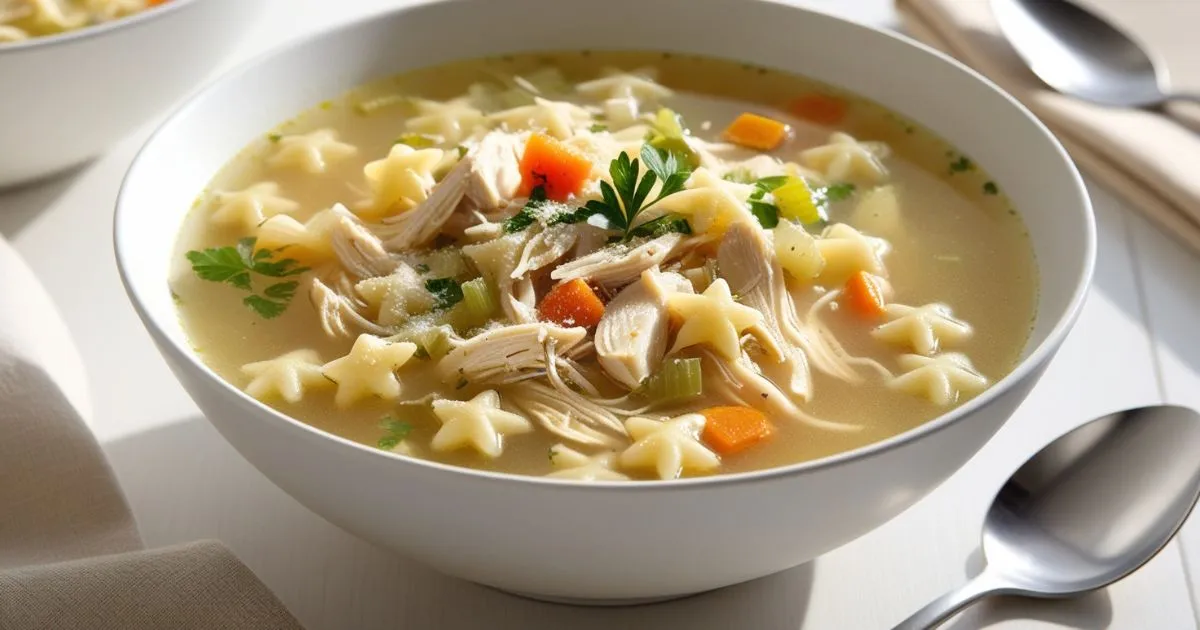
[0, 238, 300, 630]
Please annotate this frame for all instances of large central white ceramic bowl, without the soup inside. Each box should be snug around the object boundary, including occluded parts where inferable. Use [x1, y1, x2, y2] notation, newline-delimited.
[115, 0, 1096, 601]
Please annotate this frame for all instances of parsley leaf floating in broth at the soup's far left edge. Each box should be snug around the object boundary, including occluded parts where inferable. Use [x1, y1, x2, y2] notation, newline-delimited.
[185, 236, 308, 319]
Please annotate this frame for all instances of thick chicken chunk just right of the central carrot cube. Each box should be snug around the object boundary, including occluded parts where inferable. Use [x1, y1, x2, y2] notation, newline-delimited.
[595, 270, 692, 390]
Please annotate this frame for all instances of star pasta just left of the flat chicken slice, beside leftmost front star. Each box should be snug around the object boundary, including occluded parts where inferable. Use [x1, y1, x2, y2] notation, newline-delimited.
[320, 334, 416, 408]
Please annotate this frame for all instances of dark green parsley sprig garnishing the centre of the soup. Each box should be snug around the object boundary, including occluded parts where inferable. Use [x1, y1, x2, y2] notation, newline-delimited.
[573, 143, 691, 241]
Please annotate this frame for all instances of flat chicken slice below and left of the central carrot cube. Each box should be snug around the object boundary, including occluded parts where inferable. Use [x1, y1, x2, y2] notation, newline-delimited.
[437, 324, 587, 383]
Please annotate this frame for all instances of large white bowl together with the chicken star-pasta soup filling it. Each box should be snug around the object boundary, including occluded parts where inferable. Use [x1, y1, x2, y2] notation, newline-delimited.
[116, 0, 1094, 600]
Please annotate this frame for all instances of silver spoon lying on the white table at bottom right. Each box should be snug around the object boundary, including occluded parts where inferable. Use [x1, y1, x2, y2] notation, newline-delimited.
[895, 406, 1200, 630]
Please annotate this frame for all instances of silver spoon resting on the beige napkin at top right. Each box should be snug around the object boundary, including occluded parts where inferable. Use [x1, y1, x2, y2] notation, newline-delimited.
[991, 0, 1200, 107]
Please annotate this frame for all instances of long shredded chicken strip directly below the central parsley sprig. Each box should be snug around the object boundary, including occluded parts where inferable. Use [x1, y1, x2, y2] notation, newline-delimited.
[550, 234, 695, 289]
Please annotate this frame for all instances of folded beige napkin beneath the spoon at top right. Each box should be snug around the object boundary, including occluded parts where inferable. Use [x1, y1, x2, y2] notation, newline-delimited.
[895, 0, 1200, 252]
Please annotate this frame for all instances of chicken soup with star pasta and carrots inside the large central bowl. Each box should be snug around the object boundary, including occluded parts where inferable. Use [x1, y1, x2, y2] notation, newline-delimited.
[172, 52, 1036, 481]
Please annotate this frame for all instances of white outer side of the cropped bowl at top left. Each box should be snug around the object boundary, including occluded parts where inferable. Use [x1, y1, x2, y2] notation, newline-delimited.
[0, 0, 260, 188]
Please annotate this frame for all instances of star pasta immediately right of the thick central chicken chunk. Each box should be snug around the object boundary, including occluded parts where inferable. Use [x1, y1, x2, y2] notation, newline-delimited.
[667, 278, 762, 360]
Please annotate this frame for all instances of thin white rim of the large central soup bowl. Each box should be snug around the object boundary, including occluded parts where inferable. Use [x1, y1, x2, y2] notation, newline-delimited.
[113, 0, 1097, 492]
